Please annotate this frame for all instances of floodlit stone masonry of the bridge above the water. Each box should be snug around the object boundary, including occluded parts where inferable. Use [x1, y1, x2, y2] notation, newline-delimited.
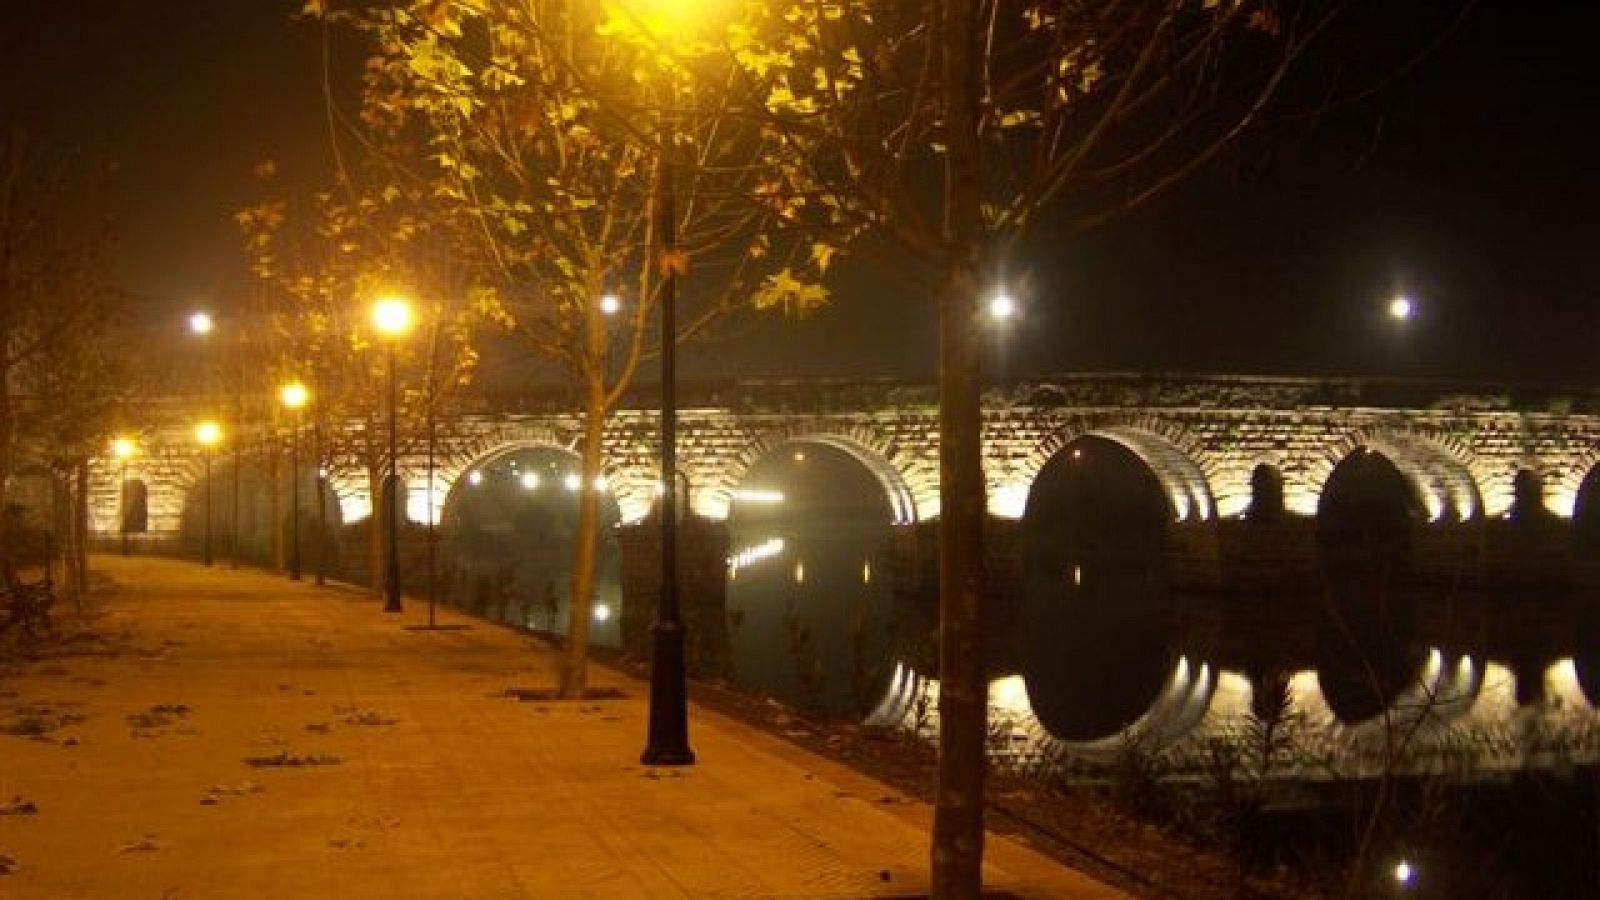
[91, 376, 1600, 535]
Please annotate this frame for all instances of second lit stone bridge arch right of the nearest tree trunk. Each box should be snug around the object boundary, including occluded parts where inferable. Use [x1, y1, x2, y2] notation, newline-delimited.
[1283, 429, 1484, 520]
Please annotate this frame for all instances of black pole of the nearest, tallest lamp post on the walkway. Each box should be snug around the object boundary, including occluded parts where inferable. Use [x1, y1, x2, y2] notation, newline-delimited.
[640, 103, 694, 765]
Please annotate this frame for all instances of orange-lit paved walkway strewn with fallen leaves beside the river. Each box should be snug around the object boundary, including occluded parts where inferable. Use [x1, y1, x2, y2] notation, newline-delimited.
[0, 557, 1120, 900]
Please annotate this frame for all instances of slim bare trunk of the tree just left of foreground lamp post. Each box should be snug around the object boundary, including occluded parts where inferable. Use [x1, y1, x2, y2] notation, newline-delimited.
[562, 293, 606, 700]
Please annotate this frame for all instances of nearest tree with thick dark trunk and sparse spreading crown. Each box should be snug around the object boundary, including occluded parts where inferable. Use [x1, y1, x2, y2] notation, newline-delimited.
[730, 0, 1342, 897]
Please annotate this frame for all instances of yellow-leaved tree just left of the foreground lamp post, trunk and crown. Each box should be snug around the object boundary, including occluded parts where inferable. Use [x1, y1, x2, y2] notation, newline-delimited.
[309, 0, 829, 697]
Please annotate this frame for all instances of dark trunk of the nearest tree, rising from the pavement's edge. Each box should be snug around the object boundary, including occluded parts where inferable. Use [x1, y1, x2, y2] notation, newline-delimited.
[931, 0, 987, 900]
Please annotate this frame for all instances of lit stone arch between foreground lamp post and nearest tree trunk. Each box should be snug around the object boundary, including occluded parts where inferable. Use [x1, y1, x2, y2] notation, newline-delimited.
[707, 421, 939, 524]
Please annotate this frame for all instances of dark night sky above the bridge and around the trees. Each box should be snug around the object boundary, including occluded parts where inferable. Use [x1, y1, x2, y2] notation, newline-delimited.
[0, 0, 1600, 384]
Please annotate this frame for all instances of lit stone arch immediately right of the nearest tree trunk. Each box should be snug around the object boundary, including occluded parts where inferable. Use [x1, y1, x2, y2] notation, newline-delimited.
[987, 415, 1222, 522]
